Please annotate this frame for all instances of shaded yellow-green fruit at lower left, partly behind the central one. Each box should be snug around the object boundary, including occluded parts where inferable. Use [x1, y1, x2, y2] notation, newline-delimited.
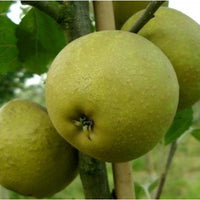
[0, 100, 78, 198]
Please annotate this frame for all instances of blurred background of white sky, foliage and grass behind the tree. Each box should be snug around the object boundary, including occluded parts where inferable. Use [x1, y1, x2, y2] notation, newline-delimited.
[0, 0, 200, 199]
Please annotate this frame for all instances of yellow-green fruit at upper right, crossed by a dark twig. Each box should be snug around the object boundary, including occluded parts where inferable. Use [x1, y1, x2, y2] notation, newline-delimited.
[122, 7, 200, 109]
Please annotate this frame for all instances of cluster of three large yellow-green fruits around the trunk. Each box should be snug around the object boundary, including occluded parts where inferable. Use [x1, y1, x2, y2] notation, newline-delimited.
[0, 2, 200, 197]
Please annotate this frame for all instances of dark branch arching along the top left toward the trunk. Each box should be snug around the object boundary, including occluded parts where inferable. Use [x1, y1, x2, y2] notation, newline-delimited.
[21, 1, 61, 23]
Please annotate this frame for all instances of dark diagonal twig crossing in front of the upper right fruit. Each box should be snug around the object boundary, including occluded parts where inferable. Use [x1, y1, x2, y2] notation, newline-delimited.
[129, 1, 165, 33]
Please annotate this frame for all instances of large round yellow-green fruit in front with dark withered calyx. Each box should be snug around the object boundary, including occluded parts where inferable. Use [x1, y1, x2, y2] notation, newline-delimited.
[46, 30, 179, 162]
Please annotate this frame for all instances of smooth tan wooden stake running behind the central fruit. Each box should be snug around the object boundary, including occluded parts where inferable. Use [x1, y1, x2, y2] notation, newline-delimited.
[93, 1, 135, 199]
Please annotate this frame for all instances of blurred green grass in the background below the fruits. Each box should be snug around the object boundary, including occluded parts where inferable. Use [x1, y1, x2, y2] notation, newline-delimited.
[1, 133, 200, 199]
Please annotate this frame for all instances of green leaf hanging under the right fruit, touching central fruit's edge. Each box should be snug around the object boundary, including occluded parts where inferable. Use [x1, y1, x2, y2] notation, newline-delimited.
[165, 107, 193, 145]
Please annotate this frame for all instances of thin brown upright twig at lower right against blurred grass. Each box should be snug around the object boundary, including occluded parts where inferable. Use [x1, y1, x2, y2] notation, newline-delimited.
[155, 141, 178, 199]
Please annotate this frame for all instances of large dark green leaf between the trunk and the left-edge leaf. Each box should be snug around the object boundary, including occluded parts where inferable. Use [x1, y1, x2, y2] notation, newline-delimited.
[16, 8, 66, 74]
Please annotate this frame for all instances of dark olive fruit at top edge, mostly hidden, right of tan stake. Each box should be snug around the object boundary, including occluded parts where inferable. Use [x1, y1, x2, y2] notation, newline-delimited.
[113, 1, 168, 29]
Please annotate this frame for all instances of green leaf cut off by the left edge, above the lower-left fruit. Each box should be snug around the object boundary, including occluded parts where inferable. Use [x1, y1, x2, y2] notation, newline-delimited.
[0, 15, 21, 74]
